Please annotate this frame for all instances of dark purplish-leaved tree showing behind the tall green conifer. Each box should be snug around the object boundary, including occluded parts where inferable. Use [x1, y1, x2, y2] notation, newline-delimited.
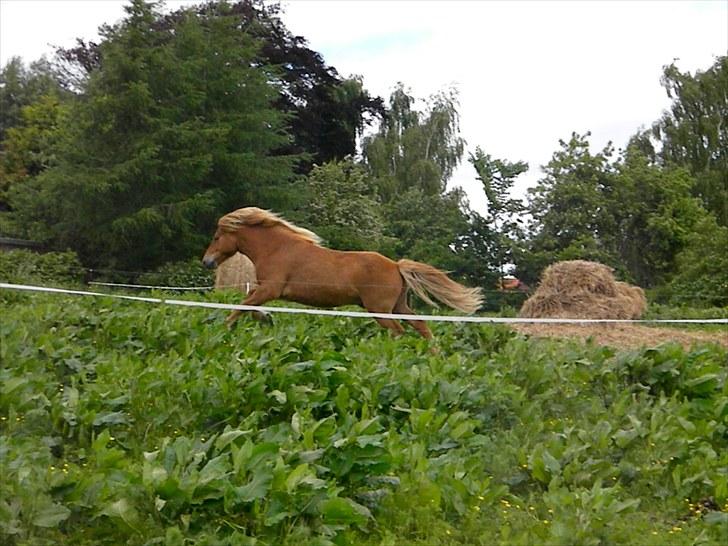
[54, 0, 383, 173]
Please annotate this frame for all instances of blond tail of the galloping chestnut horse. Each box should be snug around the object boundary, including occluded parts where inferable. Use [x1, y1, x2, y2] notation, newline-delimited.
[397, 260, 483, 314]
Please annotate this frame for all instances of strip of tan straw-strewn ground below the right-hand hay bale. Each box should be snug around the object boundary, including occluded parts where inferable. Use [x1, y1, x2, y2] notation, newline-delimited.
[513, 324, 728, 348]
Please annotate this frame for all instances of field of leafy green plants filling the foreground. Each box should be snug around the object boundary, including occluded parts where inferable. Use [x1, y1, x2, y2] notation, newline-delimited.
[0, 295, 728, 546]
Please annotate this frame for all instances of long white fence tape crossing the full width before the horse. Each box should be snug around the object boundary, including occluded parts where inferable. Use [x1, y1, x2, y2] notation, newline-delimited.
[0, 283, 728, 324]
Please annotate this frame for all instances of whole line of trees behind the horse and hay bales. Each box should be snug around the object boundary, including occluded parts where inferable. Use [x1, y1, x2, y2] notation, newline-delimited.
[0, 0, 728, 305]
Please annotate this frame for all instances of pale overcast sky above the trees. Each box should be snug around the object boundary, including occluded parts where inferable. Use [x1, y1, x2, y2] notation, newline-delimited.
[0, 0, 728, 209]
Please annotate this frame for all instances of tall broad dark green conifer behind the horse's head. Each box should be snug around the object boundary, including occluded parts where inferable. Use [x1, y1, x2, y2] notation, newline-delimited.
[13, 0, 296, 270]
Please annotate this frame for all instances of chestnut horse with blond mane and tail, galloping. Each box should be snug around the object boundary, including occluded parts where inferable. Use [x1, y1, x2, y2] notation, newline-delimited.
[202, 207, 483, 339]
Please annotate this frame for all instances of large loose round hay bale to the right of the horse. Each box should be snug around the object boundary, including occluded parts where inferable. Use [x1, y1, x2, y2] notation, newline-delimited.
[519, 260, 647, 319]
